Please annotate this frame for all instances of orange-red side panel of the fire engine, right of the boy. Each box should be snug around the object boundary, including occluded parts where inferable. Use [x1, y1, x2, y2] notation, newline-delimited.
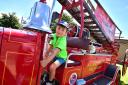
[56, 54, 111, 85]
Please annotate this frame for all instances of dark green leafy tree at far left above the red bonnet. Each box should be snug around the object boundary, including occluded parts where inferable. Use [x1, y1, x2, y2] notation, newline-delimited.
[0, 13, 21, 29]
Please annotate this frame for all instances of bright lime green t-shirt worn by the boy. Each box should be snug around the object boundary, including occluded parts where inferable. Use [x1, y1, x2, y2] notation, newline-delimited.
[50, 34, 67, 60]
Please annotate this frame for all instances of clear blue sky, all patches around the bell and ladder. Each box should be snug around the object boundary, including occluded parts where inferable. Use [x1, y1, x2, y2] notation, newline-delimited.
[0, 0, 128, 39]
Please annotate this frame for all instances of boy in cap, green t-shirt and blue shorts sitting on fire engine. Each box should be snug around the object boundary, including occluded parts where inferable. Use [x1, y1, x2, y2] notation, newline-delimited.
[41, 21, 68, 85]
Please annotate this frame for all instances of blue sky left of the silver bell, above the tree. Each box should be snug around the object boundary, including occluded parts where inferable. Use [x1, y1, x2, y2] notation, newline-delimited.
[0, 0, 38, 18]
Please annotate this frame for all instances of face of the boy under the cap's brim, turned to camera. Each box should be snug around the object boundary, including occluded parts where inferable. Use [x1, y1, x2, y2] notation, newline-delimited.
[56, 25, 67, 37]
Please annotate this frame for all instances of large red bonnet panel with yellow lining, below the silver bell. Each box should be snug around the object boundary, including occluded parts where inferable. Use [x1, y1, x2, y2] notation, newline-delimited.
[0, 28, 42, 85]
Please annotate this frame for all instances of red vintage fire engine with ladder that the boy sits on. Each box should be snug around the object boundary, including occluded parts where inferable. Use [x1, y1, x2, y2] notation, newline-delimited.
[0, 0, 120, 85]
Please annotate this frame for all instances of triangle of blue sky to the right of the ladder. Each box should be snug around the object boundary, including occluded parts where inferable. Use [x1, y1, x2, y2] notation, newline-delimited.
[99, 0, 128, 39]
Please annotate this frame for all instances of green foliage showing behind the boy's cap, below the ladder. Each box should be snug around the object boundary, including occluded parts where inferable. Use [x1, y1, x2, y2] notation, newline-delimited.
[51, 13, 75, 33]
